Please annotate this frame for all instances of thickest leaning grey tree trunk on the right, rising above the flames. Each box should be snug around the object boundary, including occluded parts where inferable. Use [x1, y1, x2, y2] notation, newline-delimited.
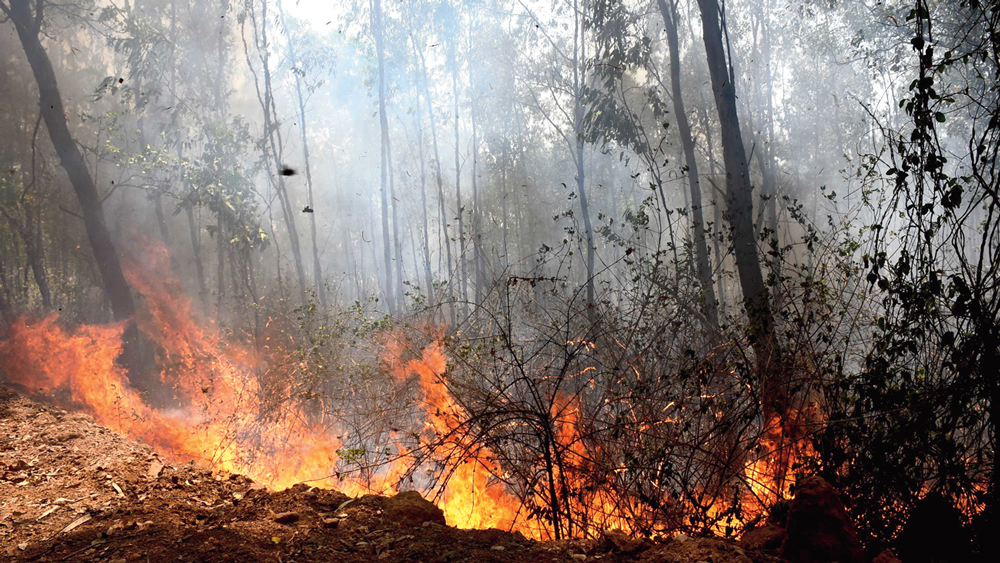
[698, 0, 776, 366]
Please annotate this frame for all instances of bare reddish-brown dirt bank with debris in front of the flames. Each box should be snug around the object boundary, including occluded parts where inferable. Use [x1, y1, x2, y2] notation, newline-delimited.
[0, 386, 773, 563]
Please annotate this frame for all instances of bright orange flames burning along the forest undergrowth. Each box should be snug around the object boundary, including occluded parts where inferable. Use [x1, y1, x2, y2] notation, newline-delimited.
[0, 247, 804, 539]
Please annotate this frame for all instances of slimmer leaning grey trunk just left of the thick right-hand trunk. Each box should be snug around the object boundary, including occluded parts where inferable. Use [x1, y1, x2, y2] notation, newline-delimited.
[658, 0, 719, 329]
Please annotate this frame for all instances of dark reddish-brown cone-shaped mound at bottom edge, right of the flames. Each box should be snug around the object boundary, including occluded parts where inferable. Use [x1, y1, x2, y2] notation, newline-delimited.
[781, 477, 864, 563]
